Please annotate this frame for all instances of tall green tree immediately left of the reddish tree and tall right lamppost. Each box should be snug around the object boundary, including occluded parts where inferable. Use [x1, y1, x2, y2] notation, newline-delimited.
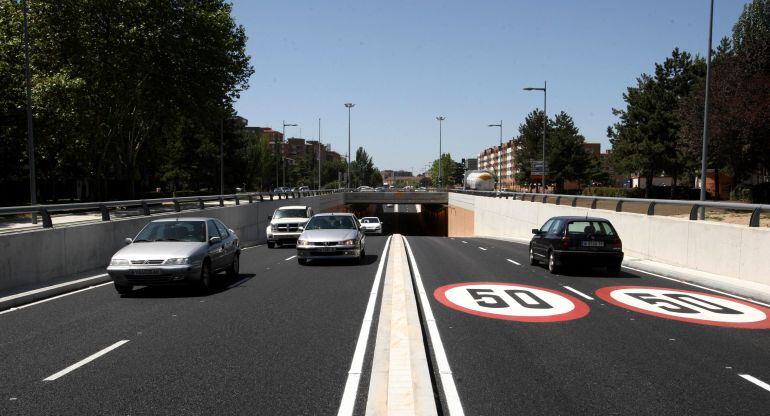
[607, 48, 704, 198]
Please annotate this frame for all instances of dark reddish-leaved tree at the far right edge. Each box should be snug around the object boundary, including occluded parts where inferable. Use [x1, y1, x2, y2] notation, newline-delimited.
[677, 0, 770, 194]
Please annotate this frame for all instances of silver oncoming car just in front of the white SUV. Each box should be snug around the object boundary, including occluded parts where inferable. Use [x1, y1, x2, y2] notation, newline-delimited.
[297, 213, 366, 264]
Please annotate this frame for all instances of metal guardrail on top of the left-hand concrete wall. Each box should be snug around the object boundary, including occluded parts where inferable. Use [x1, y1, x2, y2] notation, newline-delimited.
[0, 189, 345, 228]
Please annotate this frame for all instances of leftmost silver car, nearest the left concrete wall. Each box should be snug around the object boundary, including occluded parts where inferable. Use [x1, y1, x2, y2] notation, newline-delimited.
[107, 218, 241, 294]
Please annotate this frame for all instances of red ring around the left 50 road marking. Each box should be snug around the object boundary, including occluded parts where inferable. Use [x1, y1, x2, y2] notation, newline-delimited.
[433, 282, 591, 322]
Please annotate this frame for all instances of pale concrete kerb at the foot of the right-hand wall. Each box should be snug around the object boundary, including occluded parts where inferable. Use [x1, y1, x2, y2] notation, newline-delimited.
[474, 236, 770, 303]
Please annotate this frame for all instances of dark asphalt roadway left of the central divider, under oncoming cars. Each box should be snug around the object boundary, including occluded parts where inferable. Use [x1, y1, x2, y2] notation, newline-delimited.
[0, 236, 386, 415]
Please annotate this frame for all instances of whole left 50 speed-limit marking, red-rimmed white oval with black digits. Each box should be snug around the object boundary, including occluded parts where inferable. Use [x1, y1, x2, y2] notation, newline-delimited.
[433, 282, 590, 322]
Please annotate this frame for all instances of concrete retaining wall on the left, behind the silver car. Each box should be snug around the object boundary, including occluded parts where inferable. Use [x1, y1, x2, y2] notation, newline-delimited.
[0, 194, 344, 292]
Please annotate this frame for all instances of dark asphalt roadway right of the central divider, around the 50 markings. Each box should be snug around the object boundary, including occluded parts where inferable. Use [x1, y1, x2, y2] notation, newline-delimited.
[408, 237, 770, 415]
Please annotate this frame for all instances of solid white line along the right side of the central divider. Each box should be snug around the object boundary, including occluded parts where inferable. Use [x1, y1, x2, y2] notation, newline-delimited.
[404, 237, 464, 416]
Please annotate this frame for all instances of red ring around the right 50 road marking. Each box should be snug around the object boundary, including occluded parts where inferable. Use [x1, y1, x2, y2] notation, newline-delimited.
[596, 286, 770, 329]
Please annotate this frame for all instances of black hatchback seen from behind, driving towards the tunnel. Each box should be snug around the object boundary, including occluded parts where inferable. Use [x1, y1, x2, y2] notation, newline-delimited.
[529, 217, 623, 275]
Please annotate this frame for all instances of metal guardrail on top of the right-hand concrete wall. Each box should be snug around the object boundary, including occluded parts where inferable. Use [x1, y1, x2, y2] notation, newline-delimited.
[450, 189, 770, 227]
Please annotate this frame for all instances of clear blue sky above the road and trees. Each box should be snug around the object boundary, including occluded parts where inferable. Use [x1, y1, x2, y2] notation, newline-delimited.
[234, 0, 745, 171]
